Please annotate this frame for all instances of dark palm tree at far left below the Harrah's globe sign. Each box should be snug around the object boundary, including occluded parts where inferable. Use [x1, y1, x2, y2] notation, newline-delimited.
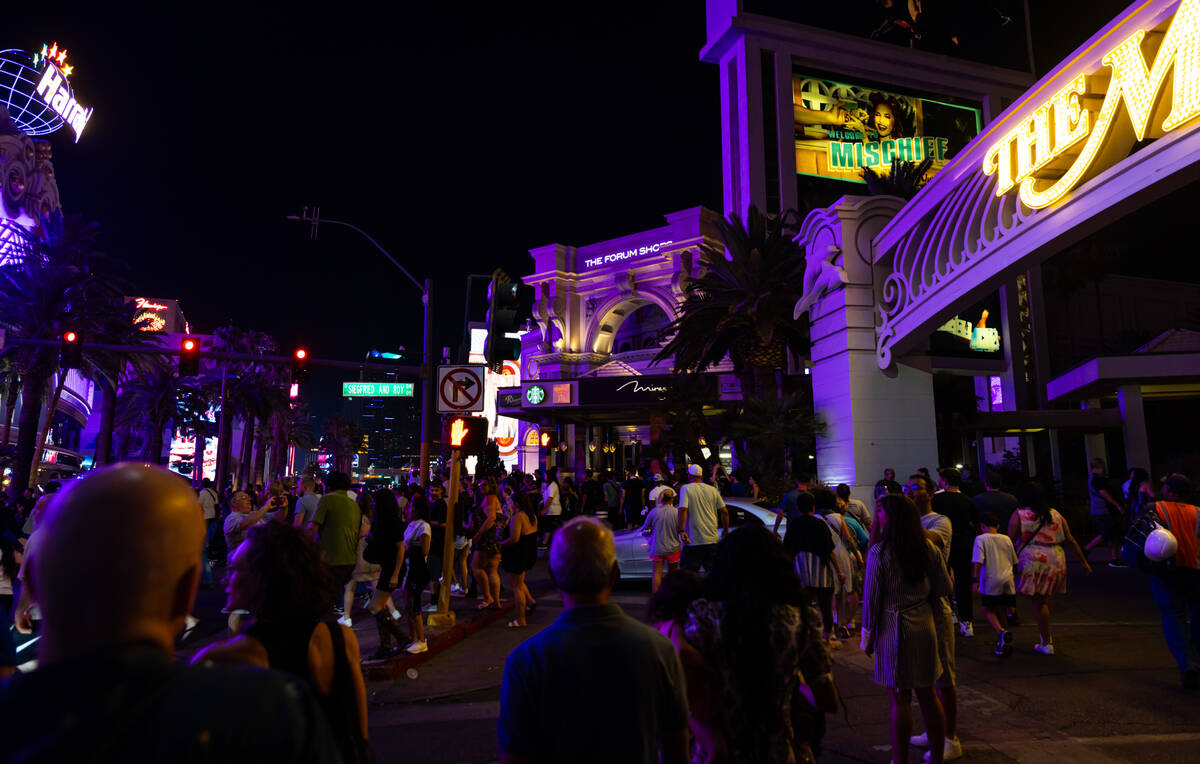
[0, 213, 121, 495]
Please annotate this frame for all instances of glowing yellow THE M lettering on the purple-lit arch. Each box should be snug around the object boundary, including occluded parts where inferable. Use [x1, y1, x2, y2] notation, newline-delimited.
[983, 0, 1200, 209]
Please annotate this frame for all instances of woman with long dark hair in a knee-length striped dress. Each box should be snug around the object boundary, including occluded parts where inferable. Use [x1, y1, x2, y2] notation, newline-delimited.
[862, 494, 950, 764]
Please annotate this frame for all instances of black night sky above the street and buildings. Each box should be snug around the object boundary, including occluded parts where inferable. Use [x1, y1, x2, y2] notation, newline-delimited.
[9, 0, 1142, 417]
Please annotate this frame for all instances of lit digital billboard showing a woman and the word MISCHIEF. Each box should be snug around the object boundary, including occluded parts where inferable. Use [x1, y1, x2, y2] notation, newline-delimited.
[792, 73, 980, 182]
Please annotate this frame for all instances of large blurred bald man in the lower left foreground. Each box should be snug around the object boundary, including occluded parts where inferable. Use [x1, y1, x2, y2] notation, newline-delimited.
[0, 463, 338, 764]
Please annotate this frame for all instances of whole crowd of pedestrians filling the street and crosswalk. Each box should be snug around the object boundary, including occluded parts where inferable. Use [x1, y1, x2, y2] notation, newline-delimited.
[0, 450, 1200, 762]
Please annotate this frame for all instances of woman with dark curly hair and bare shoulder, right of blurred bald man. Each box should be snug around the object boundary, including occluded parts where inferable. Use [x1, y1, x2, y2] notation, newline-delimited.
[192, 523, 368, 762]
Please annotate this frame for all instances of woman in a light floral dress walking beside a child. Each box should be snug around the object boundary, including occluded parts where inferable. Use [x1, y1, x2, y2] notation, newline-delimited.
[1008, 482, 1092, 655]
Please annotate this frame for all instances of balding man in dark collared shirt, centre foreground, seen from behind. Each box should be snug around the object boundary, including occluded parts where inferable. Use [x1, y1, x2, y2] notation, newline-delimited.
[497, 517, 688, 764]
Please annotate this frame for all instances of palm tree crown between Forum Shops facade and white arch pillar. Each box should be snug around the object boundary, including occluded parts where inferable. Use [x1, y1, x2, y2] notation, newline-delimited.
[654, 206, 809, 397]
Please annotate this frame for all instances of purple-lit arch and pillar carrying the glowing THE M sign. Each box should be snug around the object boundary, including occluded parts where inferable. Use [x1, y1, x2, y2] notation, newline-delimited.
[797, 0, 1200, 496]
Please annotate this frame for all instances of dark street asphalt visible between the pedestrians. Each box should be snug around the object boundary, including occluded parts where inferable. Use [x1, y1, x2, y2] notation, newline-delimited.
[180, 553, 1200, 764]
